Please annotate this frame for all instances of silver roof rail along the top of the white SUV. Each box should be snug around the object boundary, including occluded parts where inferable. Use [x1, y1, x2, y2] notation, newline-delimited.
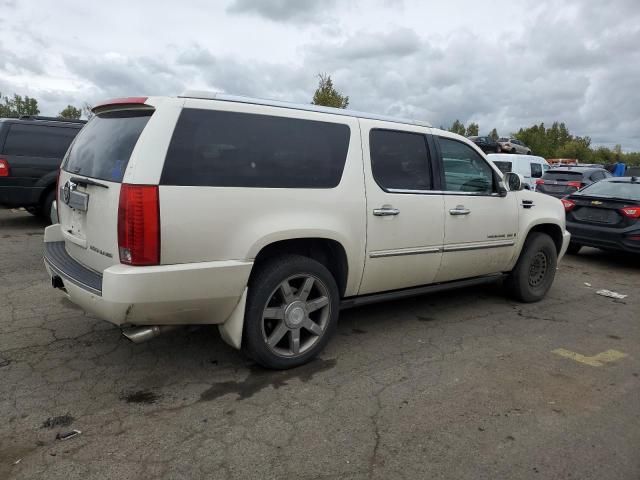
[178, 90, 432, 127]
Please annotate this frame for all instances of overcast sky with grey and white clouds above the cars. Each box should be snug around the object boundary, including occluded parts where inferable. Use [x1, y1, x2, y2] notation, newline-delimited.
[0, 0, 640, 150]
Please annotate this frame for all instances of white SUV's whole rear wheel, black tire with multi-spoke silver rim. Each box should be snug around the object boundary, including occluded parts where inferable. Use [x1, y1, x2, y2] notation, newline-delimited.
[242, 255, 340, 370]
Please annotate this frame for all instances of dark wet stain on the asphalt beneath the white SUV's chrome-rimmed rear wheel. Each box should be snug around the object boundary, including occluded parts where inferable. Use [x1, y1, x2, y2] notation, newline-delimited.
[200, 359, 336, 402]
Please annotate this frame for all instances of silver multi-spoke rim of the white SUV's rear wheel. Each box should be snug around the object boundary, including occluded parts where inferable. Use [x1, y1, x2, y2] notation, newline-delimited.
[262, 274, 331, 357]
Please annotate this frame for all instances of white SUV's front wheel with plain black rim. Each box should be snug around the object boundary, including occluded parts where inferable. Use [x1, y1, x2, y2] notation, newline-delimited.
[505, 232, 558, 303]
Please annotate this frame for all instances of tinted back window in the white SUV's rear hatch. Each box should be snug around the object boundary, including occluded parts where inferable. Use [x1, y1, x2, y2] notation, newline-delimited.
[63, 109, 153, 182]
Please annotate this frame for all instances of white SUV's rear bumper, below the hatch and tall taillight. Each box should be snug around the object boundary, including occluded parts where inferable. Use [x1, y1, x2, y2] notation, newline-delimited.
[44, 225, 253, 326]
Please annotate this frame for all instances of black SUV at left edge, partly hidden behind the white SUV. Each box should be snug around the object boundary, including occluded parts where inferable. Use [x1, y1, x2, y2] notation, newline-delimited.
[0, 116, 86, 221]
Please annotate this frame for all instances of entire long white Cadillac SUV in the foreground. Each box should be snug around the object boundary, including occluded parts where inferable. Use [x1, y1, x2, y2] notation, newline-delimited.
[44, 92, 569, 368]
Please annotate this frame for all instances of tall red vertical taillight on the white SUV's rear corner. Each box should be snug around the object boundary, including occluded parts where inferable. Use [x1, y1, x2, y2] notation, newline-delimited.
[118, 183, 160, 265]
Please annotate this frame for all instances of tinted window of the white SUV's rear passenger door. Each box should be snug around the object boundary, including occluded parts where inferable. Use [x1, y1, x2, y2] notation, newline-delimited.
[369, 130, 431, 190]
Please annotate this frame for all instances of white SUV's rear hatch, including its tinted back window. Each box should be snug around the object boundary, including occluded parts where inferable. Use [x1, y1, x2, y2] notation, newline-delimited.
[58, 105, 154, 272]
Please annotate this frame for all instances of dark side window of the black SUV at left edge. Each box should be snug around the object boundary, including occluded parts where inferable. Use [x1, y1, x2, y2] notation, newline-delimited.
[4, 123, 80, 158]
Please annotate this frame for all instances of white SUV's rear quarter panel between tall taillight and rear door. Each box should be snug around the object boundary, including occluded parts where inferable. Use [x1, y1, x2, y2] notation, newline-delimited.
[156, 99, 366, 295]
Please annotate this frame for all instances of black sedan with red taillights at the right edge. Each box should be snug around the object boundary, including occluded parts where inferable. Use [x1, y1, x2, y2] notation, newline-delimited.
[562, 177, 640, 254]
